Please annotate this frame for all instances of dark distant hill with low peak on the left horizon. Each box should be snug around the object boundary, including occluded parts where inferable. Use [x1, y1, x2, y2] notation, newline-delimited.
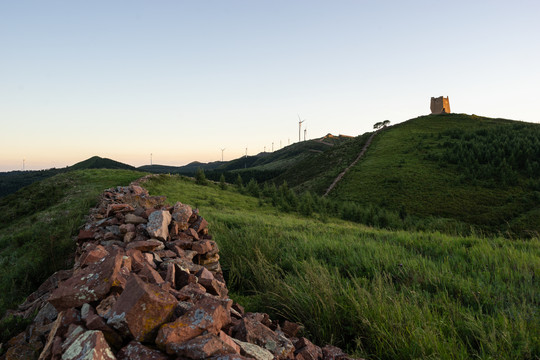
[0, 156, 135, 197]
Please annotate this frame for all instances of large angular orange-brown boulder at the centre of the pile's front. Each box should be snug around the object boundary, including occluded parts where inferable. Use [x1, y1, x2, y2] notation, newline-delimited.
[107, 274, 177, 342]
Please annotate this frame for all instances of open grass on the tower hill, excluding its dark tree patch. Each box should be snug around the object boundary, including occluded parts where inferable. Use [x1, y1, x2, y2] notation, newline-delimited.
[330, 114, 540, 235]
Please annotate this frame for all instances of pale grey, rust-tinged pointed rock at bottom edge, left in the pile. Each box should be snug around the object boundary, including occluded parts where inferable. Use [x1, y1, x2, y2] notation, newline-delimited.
[62, 330, 116, 360]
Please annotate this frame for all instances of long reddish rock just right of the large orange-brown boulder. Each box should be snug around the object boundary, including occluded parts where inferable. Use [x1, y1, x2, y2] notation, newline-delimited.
[156, 298, 231, 354]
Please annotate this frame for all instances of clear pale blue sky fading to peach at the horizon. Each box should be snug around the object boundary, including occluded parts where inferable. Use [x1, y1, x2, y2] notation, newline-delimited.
[0, 0, 540, 171]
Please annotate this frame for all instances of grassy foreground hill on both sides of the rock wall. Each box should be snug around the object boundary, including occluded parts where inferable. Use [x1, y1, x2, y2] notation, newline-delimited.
[0, 170, 540, 359]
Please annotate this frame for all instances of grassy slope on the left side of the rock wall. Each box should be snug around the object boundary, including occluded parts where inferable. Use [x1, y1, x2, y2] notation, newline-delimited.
[0, 170, 144, 325]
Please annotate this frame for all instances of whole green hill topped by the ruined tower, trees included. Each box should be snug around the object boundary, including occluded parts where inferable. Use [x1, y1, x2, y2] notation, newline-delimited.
[330, 114, 540, 234]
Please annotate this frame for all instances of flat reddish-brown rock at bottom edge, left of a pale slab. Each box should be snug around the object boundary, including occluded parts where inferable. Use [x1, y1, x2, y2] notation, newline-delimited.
[167, 333, 235, 359]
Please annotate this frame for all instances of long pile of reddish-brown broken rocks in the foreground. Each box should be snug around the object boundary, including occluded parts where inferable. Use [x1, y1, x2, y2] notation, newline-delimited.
[0, 184, 358, 360]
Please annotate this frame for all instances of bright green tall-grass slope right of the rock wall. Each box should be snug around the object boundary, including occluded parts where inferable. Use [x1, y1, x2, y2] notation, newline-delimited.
[145, 176, 540, 359]
